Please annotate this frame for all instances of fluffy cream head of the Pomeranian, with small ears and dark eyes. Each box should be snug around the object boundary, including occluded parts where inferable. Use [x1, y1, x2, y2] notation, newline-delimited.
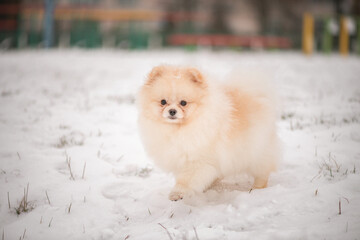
[139, 66, 207, 124]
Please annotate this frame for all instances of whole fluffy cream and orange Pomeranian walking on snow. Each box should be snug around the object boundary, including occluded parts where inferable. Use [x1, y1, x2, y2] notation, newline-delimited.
[137, 65, 279, 201]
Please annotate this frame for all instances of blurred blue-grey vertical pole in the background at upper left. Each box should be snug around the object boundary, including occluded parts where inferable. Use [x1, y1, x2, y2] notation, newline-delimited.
[44, 0, 55, 48]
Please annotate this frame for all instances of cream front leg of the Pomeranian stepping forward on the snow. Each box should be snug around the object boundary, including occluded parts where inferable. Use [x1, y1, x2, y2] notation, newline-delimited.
[169, 161, 219, 201]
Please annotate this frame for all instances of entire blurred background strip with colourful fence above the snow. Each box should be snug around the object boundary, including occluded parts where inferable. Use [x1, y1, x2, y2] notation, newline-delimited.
[0, 0, 360, 54]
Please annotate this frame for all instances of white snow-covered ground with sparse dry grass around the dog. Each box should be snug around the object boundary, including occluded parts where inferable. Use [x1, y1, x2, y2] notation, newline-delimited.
[0, 50, 360, 240]
